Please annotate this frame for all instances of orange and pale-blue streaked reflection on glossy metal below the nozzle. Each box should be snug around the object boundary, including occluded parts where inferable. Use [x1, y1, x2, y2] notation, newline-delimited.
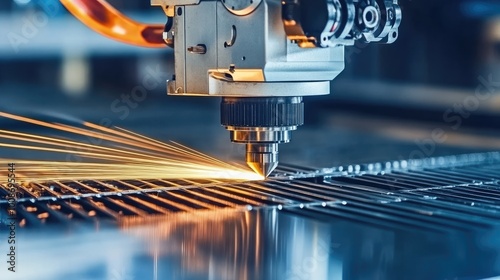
[120, 210, 342, 279]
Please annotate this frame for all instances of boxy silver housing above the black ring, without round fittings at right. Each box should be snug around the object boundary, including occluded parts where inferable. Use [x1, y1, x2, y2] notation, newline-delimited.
[164, 0, 350, 96]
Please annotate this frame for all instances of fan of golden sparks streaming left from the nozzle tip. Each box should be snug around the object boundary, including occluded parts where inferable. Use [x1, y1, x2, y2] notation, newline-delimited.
[0, 112, 263, 185]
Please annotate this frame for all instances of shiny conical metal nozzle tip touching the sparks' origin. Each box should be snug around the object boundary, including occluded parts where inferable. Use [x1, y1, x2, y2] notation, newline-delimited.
[246, 143, 278, 178]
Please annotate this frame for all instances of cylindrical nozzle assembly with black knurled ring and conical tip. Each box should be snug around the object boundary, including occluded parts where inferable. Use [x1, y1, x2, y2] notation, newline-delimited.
[221, 97, 304, 177]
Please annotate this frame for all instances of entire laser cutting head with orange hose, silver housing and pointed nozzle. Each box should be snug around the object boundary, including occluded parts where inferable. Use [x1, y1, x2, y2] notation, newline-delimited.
[61, 0, 402, 177]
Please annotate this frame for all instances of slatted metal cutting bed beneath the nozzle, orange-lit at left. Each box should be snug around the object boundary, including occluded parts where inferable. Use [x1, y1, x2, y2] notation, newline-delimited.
[0, 152, 500, 230]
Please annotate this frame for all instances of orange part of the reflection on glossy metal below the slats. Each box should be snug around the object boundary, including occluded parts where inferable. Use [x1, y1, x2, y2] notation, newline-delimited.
[120, 210, 262, 279]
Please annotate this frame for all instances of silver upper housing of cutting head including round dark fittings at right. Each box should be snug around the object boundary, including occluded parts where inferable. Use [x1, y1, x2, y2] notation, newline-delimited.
[153, 0, 401, 93]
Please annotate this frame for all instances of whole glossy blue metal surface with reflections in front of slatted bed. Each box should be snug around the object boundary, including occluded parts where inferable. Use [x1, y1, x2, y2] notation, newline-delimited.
[4, 209, 500, 280]
